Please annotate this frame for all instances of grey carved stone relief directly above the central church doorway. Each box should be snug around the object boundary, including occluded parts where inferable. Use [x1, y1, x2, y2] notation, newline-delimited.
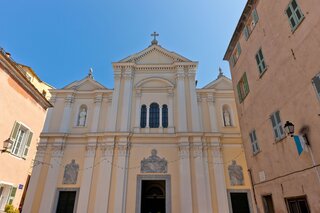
[141, 149, 168, 173]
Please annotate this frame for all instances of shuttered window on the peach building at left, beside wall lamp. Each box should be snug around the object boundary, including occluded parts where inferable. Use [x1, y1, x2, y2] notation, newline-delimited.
[7, 121, 33, 158]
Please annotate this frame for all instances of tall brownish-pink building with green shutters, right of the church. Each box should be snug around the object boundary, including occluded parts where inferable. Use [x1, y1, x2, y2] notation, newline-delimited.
[224, 0, 320, 212]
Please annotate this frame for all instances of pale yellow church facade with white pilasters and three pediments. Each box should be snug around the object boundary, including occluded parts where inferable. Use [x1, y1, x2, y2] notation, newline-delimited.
[23, 39, 254, 213]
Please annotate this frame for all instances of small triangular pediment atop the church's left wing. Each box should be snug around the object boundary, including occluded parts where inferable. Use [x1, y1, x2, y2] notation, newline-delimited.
[63, 77, 107, 91]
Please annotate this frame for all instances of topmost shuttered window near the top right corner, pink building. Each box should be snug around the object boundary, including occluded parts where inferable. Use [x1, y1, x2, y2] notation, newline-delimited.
[286, 0, 304, 31]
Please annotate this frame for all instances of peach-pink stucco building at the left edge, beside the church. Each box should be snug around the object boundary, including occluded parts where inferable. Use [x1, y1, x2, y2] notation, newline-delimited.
[0, 49, 51, 212]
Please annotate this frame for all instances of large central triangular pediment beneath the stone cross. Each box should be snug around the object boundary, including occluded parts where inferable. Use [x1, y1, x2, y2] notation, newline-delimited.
[119, 45, 191, 64]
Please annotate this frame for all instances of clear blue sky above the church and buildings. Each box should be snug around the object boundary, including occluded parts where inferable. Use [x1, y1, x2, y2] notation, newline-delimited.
[0, 0, 246, 88]
